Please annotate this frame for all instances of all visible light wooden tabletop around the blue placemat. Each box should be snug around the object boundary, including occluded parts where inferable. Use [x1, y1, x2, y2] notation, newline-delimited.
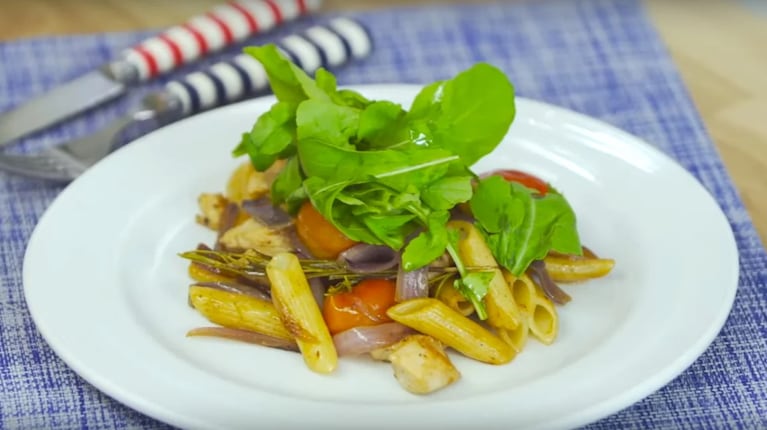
[0, 0, 767, 243]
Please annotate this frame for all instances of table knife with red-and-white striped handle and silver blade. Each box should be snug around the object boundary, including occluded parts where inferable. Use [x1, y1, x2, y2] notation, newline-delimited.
[0, 0, 322, 147]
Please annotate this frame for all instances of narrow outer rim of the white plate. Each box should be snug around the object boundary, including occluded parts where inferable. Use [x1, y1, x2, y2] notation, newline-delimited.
[23, 83, 740, 427]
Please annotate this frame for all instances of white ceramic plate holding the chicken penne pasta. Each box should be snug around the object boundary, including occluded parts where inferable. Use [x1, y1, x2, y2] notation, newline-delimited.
[24, 85, 738, 429]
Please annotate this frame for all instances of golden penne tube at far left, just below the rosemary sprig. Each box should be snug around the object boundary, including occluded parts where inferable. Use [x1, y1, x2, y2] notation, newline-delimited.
[189, 286, 293, 340]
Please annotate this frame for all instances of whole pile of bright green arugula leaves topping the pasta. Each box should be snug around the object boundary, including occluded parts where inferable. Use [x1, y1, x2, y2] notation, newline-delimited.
[233, 45, 578, 319]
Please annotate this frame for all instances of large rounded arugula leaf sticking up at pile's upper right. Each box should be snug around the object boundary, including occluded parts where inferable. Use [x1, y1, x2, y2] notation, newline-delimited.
[408, 63, 516, 166]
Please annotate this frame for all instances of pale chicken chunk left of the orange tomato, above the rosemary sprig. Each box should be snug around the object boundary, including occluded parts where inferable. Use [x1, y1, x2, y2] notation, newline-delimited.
[220, 218, 293, 256]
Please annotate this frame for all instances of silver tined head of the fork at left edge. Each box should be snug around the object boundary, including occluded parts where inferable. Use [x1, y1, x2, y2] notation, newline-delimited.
[0, 148, 88, 181]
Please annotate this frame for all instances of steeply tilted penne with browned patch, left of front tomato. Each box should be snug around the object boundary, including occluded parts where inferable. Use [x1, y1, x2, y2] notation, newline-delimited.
[266, 252, 338, 373]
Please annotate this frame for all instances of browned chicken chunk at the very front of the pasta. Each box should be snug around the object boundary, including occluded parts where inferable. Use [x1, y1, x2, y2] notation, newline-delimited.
[371, 334, 461, 394]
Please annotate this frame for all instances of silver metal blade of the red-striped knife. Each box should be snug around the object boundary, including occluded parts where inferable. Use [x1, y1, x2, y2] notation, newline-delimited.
[0, 68, 126, 146]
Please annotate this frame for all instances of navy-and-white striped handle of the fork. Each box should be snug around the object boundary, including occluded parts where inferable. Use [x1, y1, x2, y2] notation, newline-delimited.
[165, 18, 373, 116]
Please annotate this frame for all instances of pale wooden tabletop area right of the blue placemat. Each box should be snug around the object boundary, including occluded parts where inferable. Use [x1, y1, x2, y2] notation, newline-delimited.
[648, 0, 767, 244]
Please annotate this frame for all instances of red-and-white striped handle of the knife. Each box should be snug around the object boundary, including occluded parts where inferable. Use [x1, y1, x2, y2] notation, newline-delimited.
[121, 0, 322, 81]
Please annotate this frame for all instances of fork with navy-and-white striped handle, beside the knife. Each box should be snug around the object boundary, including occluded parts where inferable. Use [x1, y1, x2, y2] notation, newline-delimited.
[0, 17, 372, 182]
